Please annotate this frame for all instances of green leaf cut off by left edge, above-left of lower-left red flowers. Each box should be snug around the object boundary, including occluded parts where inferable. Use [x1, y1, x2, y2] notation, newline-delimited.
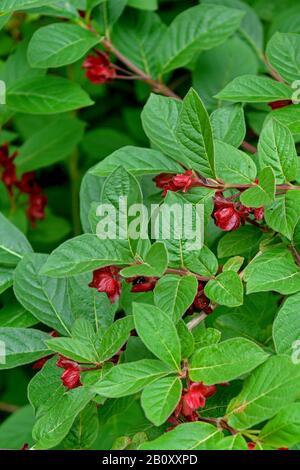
[0, 328, 49, 370]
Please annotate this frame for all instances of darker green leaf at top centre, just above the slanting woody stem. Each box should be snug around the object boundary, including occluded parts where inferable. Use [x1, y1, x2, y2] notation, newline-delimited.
[112, 10, 166, 77]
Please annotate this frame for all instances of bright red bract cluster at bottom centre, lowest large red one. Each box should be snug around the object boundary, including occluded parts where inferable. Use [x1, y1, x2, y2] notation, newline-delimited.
[168, 382, 217, 429]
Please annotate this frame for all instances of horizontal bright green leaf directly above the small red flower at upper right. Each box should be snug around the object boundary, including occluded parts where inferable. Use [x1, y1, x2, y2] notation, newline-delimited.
[215, 75, 293, 103]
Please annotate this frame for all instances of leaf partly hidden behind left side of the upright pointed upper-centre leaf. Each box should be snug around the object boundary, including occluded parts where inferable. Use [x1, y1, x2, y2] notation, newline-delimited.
[141, 93, 182, 160]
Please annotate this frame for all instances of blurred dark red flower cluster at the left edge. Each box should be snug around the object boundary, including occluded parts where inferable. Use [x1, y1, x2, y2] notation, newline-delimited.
[0, 144, 47, 226]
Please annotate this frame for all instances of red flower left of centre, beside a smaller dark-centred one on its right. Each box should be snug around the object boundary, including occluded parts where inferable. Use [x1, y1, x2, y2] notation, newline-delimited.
[89, 266, 122, 304]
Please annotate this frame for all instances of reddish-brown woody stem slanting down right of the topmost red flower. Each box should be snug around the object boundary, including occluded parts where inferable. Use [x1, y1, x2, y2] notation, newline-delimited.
[101, 39, 181, 100]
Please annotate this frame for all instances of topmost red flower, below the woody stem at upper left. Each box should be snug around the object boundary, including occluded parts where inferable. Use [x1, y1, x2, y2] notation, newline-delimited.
[82, 51, 117, 85]
